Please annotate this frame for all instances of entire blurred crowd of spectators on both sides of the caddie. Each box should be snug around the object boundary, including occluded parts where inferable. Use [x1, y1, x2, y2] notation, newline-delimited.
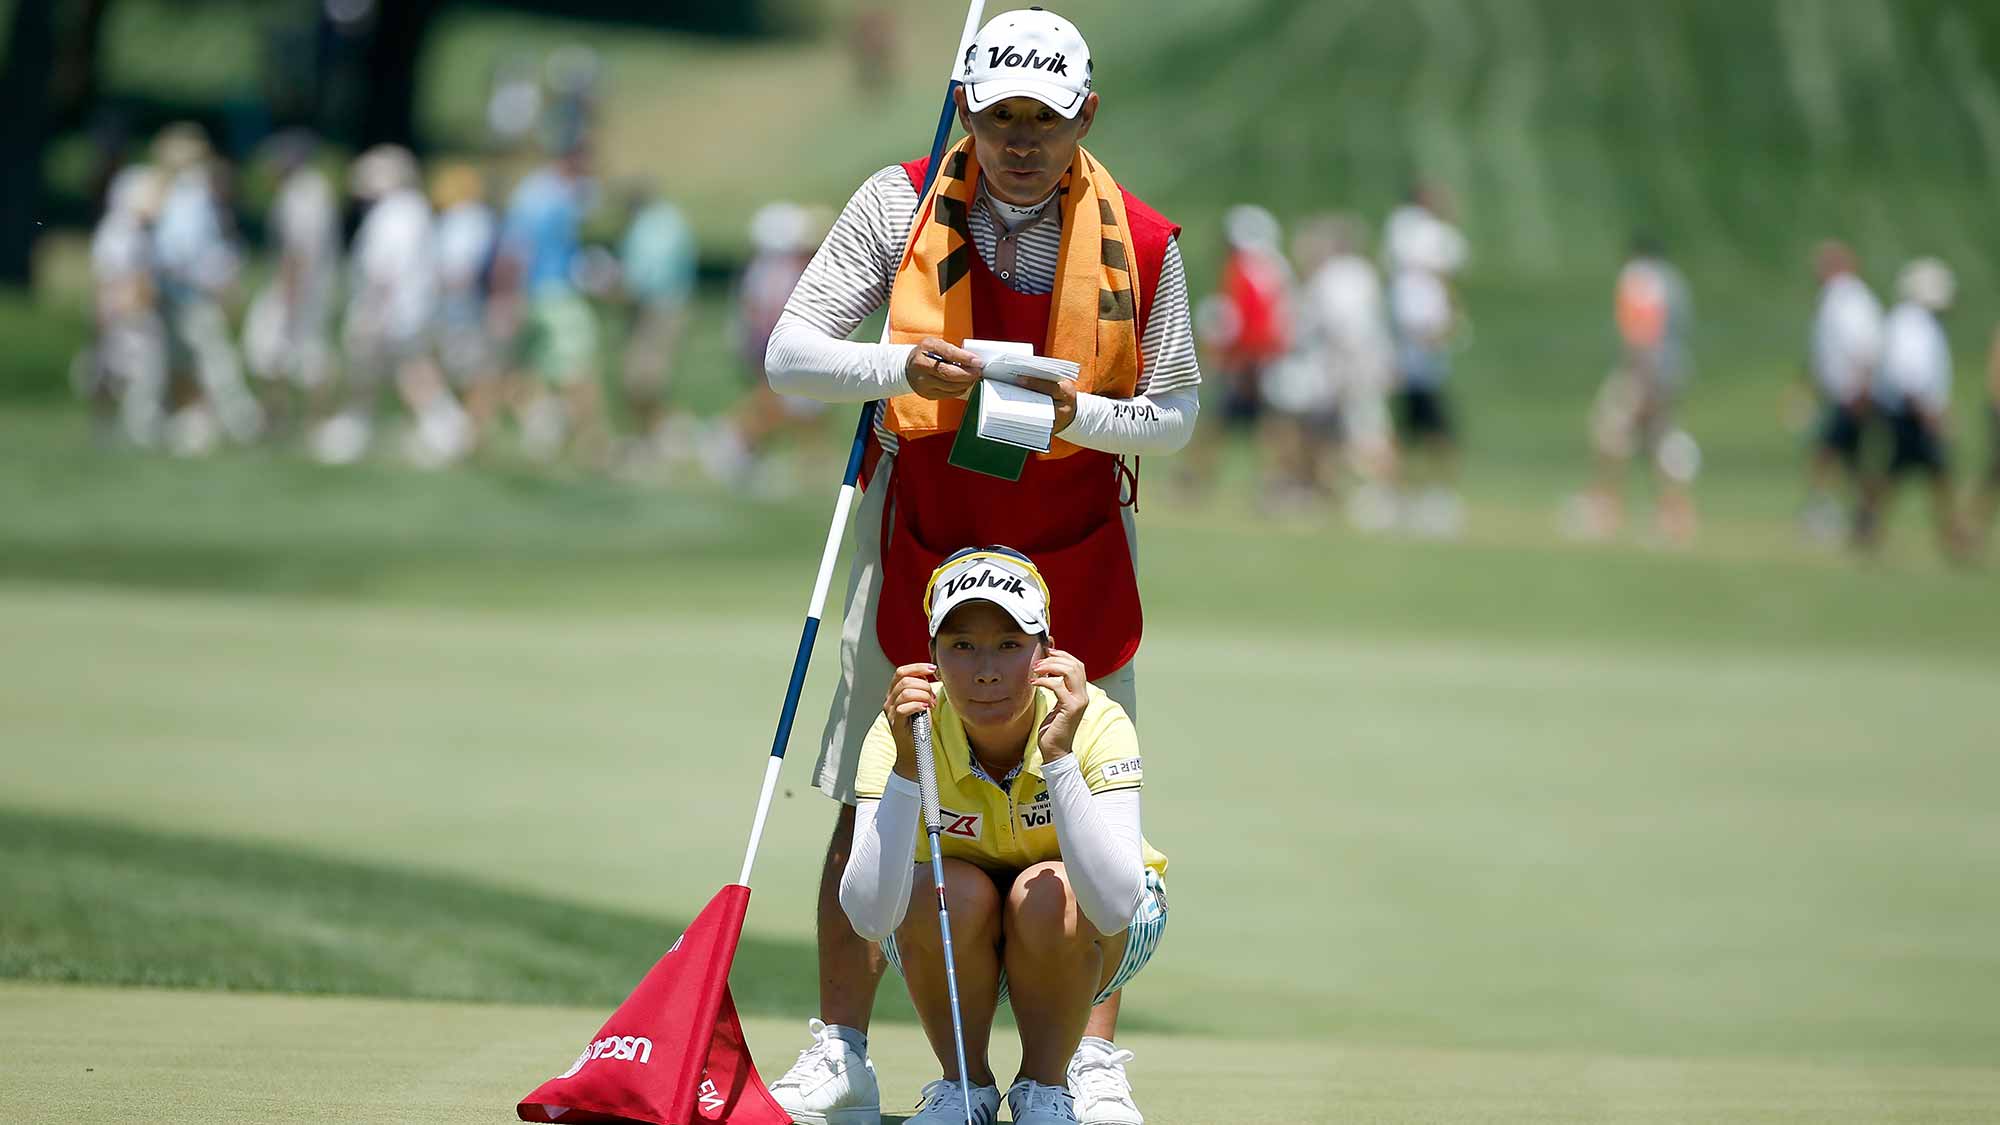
[74, 41, 2000, 558]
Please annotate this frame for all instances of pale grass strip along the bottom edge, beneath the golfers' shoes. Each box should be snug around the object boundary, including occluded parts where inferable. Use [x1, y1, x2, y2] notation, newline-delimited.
[0, 983, 2000, 1125]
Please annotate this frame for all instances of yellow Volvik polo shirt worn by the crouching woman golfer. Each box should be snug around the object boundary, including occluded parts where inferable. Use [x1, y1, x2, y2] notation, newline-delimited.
[854, 685, 1166, 877]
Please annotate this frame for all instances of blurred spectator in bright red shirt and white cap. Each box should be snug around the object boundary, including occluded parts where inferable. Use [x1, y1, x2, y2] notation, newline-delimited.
[1182, 204, 1294, 498]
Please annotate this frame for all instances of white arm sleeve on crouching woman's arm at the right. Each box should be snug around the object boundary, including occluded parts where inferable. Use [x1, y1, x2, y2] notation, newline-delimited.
[1042, 755, 1146, 935]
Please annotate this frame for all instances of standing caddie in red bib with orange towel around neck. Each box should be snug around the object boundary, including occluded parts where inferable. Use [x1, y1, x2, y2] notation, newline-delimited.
[766, 8, 1200, 1125]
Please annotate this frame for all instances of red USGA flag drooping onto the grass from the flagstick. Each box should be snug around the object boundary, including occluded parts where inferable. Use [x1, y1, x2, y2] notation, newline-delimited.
[518, 885, 792, 1125]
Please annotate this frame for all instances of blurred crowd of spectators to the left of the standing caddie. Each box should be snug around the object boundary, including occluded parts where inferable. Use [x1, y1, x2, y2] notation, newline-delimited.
[74, 48, 824, 482]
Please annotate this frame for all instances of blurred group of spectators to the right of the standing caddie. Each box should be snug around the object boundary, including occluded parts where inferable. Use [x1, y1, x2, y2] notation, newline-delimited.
[1184, 196, 2000, 558]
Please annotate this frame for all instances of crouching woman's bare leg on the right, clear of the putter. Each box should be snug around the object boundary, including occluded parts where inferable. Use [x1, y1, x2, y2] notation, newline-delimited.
[1004, 863, 1126, 1087]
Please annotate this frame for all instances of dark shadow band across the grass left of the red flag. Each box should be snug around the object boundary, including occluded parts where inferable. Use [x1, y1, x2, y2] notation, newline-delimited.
[0, 811, 856, 1019]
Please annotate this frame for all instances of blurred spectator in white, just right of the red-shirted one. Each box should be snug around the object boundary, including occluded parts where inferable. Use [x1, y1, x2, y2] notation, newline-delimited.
[1298, 214, 1396, 528]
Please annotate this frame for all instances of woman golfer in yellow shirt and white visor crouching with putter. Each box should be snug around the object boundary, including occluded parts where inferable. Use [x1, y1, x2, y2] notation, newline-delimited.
[840, 546, 1166, 1125]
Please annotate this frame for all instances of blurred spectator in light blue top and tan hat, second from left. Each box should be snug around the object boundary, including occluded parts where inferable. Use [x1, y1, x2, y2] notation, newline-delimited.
[154, 122, 264, 454]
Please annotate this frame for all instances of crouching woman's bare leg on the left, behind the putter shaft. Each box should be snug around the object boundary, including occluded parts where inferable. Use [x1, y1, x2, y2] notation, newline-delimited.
[896, 859, 1000, 1085]
